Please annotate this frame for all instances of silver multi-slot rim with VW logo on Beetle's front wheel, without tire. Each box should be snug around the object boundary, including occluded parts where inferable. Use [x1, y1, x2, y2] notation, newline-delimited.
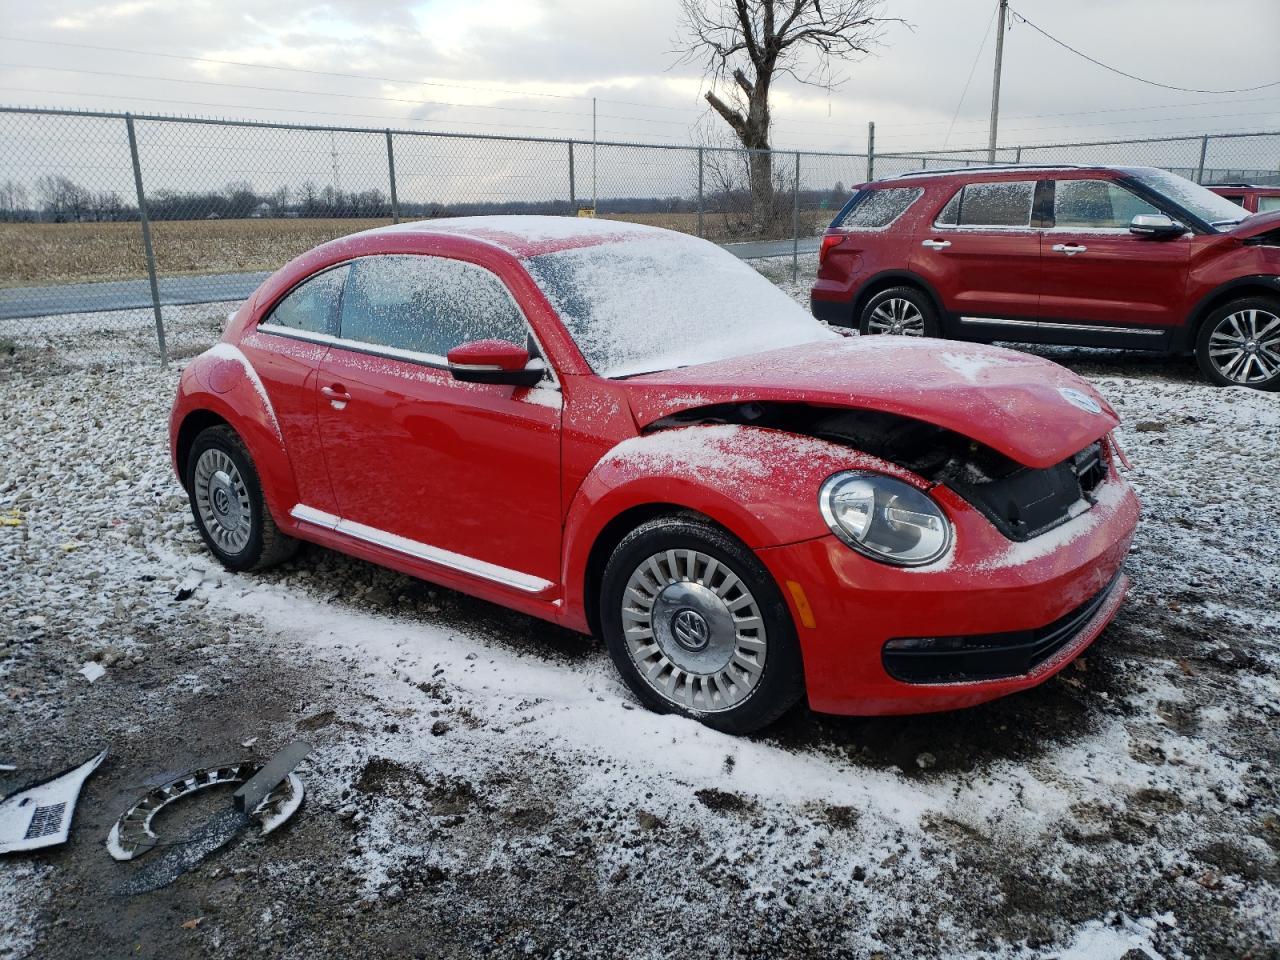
[622, 550, 768, 713]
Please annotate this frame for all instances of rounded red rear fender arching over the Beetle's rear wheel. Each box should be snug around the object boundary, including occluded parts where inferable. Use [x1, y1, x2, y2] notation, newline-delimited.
[169, 343, 298, 530]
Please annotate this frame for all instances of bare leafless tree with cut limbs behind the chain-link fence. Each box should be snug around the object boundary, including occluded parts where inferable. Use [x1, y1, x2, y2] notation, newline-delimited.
[681, 0, 895, 228]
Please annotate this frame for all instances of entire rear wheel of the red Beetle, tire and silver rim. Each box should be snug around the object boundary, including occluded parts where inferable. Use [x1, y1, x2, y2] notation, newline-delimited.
[186, 424, 300, 571]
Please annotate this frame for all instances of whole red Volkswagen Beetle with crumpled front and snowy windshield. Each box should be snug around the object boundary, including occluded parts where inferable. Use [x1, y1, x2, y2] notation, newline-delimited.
[170, 218, 1138, 732]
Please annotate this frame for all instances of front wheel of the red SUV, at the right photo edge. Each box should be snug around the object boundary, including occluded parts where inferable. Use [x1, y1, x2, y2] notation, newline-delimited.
[1196, 297, 1280, 390]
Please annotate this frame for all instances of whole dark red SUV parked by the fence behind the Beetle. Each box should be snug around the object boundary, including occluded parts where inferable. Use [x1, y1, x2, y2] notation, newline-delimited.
[810, 166, 1280, 390]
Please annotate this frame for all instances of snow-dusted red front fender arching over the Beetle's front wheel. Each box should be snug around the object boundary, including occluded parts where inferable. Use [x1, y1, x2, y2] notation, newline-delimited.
[563, 425, 929, 634]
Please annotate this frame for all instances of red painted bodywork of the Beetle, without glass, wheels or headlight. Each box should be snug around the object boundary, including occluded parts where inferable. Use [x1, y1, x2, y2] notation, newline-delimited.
[170, 220, 1138, 713]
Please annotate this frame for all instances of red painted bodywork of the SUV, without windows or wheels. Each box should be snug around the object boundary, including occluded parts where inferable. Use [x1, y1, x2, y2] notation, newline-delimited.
[810, 166, 1280, 351]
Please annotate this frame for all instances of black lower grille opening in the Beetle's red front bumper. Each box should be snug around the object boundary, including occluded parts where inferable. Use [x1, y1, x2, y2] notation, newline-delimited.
[881, 573, 1120, 684]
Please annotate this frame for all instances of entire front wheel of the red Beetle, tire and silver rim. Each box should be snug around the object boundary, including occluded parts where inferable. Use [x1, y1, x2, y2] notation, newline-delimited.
[600, 515, 804, 733]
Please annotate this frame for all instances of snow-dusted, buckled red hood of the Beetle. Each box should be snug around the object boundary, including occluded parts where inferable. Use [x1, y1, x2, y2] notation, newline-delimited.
[622, 337, 1120, 468]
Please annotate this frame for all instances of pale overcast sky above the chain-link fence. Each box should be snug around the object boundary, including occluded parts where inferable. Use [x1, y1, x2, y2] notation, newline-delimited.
[0, 0, 1280, 154]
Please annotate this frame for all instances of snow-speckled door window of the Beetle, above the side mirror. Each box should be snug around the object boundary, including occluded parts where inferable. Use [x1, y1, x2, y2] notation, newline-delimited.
[342, 256, 529, 357]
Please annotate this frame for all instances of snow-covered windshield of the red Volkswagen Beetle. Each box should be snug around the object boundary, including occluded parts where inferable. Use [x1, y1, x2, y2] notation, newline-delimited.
[525, 233, 838, 376]
